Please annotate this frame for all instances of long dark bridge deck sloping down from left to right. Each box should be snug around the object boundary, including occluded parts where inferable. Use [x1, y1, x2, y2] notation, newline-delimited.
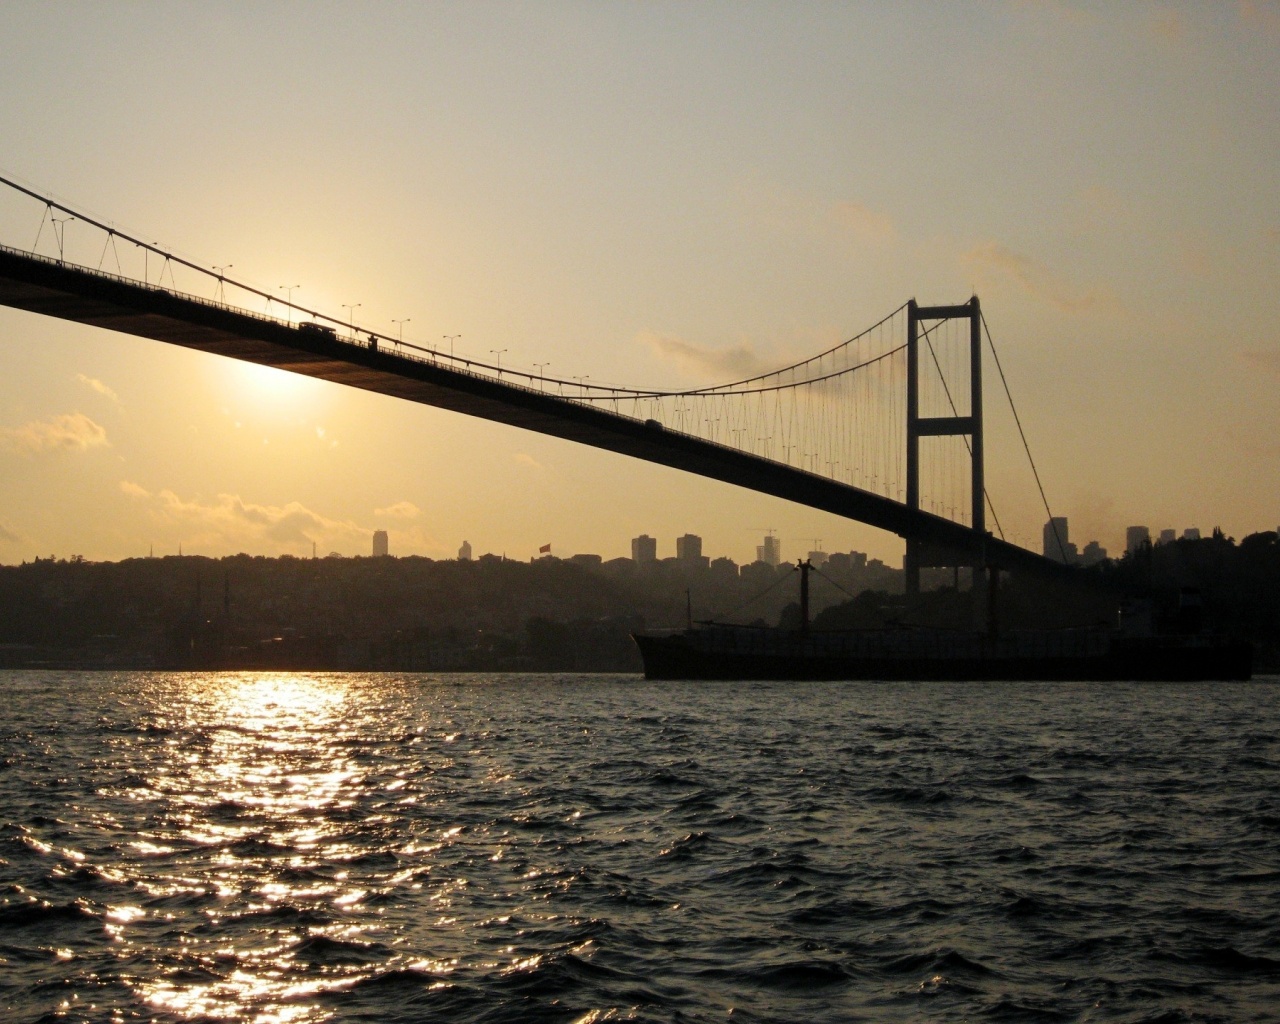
[0, 247, 1064, 575]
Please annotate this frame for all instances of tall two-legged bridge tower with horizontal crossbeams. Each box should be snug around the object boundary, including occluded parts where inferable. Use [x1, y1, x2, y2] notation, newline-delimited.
[902, 296, 987, 594]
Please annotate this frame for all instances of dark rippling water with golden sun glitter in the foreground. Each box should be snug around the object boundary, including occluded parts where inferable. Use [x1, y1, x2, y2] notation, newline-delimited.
[0, 672, 1280, 1021]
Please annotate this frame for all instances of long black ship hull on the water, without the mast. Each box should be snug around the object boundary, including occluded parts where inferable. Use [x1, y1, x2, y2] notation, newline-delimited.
[635, 634, 1253, 682]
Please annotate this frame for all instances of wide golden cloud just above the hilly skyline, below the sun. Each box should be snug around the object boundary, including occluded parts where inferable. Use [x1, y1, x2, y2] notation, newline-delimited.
[120, 480, 372, 554]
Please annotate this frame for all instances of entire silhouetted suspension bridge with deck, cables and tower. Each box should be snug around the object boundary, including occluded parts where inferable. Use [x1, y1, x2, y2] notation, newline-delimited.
[0, 178, 1070, 583]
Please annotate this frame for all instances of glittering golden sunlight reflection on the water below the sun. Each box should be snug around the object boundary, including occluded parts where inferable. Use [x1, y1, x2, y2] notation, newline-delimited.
[135, 675, 381, 1024]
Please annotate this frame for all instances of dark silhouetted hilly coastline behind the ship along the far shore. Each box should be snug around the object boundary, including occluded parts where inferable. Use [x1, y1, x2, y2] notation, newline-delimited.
[0, 532, 1280, 673]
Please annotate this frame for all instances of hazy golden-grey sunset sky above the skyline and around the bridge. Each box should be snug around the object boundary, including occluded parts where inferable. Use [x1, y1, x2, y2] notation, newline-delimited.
[0, 0, 1280, 563]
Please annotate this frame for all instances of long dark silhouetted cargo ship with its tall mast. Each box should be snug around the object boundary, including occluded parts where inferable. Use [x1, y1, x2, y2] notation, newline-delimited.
[632, 562, 1253, 682]
